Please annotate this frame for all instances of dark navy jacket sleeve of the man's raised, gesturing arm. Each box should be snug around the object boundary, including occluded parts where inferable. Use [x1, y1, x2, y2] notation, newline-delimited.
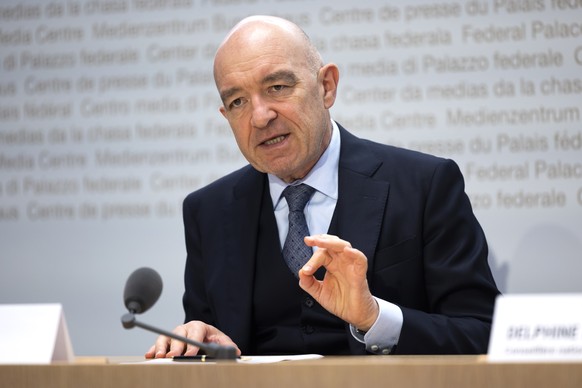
[388, 159, 499, 354]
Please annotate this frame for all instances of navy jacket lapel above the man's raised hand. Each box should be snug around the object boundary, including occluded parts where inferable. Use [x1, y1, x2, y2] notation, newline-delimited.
[330, 126, 390, 278]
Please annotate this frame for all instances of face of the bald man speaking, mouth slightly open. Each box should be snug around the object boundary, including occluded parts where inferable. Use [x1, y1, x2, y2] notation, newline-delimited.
[215, 31, 335, 182]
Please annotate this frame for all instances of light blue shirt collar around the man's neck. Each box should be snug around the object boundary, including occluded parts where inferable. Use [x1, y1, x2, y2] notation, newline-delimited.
[268, 120, 341, 208]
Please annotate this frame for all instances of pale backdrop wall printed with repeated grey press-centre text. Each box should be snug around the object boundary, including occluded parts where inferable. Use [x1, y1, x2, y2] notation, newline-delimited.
[0, 0, 582, 355]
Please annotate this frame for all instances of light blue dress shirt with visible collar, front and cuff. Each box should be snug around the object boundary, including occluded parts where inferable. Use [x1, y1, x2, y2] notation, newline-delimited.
[268, 120, 403, 354]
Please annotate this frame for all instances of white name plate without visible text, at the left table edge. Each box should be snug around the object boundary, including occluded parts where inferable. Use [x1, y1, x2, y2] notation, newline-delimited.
[0, 304, 74, 364]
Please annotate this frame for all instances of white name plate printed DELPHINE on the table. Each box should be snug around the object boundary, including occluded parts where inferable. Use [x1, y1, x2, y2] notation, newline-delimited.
[488, 294, 582, 362]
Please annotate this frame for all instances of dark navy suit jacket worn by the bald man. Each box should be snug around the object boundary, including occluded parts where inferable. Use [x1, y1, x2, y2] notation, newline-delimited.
[183, 126, 499, 354]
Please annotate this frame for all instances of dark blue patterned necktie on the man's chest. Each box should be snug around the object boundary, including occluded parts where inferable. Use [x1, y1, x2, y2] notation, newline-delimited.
[283, 184, 315, 276]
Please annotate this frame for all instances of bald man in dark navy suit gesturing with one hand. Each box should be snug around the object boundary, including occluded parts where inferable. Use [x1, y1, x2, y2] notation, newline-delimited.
[146, 16, 499, 358]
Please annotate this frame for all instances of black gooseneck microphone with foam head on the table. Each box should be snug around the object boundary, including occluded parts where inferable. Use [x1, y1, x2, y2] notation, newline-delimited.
[121, 267, 237, 360]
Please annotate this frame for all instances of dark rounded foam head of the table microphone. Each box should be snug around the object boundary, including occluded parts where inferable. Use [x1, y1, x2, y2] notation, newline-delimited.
[123, 267, 163, 314]
